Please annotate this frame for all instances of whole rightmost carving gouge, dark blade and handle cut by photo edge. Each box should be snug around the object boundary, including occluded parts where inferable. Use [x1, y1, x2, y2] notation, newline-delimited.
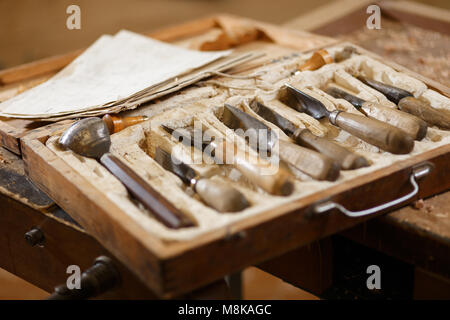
[358, 76, 450, 130]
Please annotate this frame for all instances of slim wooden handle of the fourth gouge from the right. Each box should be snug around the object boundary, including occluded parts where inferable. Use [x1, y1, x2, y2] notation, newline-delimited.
[291, 128, 369, 170]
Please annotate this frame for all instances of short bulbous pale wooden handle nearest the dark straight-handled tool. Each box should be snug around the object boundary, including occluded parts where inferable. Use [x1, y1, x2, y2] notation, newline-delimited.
[195, 179, 249, 212]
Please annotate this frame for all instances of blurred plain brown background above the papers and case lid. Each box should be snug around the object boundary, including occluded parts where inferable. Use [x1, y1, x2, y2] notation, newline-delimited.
[0, 0, 450, 69]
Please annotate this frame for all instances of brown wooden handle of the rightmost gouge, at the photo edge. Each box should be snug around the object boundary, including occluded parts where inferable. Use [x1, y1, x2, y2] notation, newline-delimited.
[398, 97, 450, 130]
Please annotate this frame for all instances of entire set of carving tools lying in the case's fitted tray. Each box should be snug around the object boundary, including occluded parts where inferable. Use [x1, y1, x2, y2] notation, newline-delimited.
[59, 48, 450, 229]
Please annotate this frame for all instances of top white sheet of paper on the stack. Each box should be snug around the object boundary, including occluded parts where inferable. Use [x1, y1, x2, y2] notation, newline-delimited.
[0, 30, 231, 118]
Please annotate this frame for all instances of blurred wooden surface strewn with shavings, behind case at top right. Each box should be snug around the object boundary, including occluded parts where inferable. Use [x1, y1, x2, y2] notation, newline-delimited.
[285, 0, 450, 86]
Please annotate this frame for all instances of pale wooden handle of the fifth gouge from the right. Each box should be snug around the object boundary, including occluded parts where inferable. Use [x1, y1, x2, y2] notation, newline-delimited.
[278, 140, 340, 181]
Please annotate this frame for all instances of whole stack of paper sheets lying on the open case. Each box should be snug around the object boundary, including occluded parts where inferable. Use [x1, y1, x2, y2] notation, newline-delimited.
[0, 30, 257, 121]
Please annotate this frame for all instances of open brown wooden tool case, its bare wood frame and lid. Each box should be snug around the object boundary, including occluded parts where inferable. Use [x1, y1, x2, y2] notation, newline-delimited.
[0, 16, 450, 297]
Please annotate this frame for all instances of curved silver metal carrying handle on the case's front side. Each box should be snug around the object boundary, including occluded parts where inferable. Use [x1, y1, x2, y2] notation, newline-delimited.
[314, 162, 433, 218]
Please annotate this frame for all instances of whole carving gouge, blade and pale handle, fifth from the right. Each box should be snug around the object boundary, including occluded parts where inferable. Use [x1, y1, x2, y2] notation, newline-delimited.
[222, 105, 339, 181]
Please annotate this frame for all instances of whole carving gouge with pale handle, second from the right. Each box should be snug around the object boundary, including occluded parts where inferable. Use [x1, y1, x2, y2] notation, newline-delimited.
[326, 87, 428, 140]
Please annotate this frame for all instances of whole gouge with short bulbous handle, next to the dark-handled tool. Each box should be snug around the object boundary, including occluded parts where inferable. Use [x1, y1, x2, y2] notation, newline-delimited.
[155, 147, 249, 212]
